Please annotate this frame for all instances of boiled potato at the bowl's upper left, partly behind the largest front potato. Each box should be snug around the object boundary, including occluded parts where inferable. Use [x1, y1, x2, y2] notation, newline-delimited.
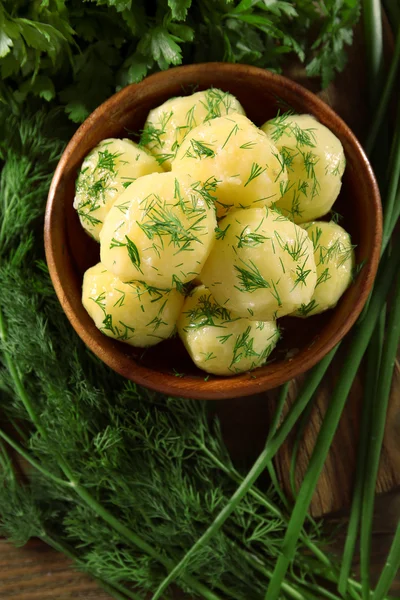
[74, 138, 163, 241]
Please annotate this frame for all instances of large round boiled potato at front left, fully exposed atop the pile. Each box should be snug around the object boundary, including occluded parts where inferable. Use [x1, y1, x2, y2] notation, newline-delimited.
[100, 173, 216, 289]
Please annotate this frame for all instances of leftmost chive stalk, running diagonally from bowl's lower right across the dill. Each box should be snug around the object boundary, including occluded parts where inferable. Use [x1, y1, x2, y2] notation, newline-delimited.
[148, 346, 338, 600]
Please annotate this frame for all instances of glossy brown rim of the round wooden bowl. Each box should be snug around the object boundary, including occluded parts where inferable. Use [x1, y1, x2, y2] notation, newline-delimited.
[44, 62, 382, 400]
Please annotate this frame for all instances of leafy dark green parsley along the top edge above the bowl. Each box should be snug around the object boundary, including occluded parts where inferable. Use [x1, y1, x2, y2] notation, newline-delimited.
[0, 0, 359, 122]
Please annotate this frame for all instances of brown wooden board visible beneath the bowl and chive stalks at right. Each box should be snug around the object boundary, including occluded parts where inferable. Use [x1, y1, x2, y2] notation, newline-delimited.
[215, 22, 400, 517]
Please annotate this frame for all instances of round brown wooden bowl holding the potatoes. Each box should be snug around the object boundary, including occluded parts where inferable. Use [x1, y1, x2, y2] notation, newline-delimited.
[45, 63, 382, 399]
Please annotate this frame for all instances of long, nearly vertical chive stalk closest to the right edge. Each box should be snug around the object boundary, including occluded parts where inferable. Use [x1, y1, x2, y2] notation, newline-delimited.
[360, 275, 400, 598]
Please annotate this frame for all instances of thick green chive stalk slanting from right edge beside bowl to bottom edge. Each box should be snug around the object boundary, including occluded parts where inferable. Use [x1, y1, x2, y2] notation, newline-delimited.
[265, 241, 400, 600]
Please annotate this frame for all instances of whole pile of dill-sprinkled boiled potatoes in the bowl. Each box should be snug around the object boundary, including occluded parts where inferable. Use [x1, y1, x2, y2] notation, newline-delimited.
[74, 88, 354, 375]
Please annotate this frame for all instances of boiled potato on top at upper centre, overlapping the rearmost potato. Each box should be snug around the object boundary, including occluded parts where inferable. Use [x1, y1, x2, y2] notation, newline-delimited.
[172, 114, 287, 217]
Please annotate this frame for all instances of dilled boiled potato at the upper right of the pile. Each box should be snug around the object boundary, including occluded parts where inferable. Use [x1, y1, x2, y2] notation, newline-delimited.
[261, 114, 346, 223]
